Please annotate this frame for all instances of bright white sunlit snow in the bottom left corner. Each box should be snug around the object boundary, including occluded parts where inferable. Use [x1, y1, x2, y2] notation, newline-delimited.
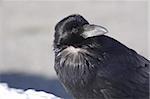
[0, 83, 62, 99]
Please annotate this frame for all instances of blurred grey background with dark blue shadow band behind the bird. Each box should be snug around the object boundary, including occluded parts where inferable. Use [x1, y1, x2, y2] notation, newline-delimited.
[0, 0, 150, 99]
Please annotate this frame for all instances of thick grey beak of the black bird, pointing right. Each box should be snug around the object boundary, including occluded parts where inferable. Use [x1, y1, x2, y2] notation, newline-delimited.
[81, 24, 108, 38]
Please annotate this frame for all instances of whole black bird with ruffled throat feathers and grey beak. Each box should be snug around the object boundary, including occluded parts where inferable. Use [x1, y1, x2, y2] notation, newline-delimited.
[54, 14, 150, 99]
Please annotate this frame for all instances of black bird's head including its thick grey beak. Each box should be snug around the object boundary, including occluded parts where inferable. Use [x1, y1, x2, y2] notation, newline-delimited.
[54, 14, 108, 47]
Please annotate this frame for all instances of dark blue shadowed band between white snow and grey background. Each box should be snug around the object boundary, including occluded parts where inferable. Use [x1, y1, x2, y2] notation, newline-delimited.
[0, 73, 72, 99]
